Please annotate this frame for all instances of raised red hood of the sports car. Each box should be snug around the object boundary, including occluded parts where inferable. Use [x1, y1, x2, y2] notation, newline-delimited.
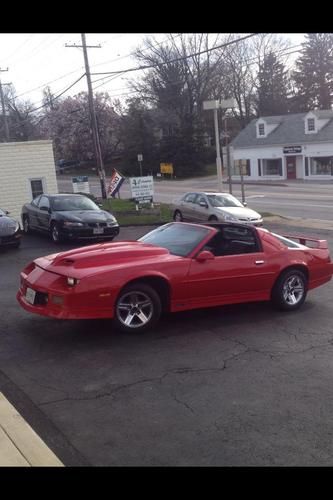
[34, 241, 174, 279]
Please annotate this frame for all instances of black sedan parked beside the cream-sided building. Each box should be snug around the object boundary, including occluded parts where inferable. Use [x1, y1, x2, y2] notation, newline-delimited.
[22, 194, 119, 243]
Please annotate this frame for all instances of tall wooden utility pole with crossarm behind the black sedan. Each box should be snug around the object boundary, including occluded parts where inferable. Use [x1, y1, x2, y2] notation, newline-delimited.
[65, 33, 106, 199]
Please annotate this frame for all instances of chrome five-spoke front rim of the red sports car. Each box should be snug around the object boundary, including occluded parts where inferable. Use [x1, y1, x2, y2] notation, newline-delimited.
[116, 291, 154, 329]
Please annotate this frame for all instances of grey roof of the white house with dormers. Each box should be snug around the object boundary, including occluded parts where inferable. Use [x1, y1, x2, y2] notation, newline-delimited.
[231, 110, 333, 148]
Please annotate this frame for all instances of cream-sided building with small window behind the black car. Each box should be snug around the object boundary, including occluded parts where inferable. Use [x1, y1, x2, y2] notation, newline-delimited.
[0, 141, 58, 220]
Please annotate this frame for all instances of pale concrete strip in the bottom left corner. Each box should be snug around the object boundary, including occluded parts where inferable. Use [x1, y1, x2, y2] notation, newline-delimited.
[0, 392, 63, 467]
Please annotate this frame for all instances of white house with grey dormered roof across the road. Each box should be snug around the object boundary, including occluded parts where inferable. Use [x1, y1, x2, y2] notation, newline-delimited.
[231, 110, 333, 180]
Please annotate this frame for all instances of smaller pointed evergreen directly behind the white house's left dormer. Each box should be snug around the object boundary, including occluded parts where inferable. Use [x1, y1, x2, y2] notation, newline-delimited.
[257, 52, 288, 116]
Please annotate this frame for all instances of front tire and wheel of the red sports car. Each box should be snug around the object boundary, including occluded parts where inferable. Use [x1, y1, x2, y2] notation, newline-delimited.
[113, 282, 162, 333]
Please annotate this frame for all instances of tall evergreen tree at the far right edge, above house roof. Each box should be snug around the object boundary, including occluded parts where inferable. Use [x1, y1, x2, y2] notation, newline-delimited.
[293, 33, 333, 112]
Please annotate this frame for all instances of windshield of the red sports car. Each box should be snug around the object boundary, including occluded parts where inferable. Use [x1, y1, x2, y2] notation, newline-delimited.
[138, 222, 210, 257]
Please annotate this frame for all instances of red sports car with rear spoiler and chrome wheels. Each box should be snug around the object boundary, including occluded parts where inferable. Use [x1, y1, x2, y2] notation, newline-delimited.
[17, 222, 333, 332]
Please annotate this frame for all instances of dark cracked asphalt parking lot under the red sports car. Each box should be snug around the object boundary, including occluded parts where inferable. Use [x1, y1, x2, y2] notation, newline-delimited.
[0, 224, 333, 466]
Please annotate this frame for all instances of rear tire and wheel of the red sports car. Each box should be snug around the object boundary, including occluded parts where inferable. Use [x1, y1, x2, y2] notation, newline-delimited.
[272, 269, 308, 311]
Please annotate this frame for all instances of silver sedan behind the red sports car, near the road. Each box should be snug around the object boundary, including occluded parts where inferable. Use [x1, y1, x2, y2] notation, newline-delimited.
[173, 192, 263, 226]
